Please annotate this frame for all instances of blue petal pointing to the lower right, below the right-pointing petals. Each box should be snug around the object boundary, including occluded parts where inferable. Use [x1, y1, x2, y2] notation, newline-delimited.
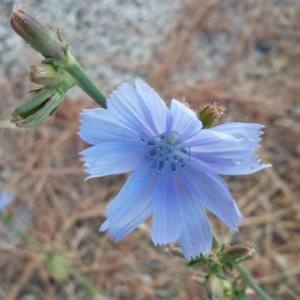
[182, 164, 242, 230]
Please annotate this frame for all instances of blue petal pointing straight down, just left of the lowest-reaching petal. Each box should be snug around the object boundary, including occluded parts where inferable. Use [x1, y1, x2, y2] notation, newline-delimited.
[151, 172, 182, 245]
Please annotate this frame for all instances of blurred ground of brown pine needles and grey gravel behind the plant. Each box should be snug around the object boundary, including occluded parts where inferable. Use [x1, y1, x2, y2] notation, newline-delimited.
[0, 0, 300, 300]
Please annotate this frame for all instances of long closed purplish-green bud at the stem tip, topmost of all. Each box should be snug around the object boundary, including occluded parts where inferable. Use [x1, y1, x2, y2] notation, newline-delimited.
[10, 6, 65, 59]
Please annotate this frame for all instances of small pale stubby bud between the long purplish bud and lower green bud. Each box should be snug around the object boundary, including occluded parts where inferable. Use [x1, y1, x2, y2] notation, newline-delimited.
[30, 64, 61, 87]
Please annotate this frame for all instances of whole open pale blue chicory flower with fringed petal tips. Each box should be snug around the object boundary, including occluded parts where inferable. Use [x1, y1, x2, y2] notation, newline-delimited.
[80, 79, 269, 260]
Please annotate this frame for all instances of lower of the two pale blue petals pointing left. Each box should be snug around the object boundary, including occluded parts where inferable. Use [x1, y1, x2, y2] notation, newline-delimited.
[80, 140, 146, 179]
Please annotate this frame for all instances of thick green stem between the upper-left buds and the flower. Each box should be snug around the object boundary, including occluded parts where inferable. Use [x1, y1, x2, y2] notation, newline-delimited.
[61, 52, 106, 108]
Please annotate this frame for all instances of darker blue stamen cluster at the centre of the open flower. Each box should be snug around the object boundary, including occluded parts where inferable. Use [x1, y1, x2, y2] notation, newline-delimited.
[141, 132, 190, 173]
